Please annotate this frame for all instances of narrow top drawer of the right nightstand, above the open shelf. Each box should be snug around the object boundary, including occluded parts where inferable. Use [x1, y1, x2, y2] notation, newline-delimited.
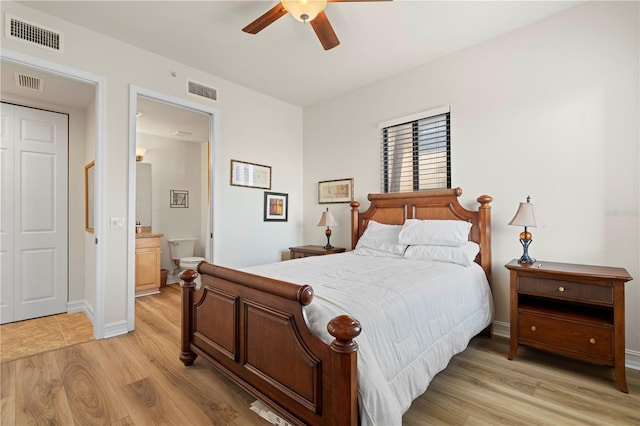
[518, 276, 613, 304]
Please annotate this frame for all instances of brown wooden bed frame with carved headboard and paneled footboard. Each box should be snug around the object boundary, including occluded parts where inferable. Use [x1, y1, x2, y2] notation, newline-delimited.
[180, 188, 492, 425]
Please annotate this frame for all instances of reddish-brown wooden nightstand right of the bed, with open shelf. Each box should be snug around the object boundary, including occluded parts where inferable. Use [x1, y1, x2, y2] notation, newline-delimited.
[505, 259, 633, 393]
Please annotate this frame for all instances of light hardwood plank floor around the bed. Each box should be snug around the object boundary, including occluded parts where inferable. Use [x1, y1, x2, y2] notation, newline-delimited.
[0, 285, 640, 426]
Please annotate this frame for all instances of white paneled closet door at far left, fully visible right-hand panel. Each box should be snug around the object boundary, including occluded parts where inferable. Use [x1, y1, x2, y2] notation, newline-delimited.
[2, 106, 68, 322]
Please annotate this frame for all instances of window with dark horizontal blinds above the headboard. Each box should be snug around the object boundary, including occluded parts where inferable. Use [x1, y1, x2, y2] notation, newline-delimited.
[380, 107, 451, 193]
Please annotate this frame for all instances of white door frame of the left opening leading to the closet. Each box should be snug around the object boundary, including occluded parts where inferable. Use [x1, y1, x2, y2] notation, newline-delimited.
[0, 48, 107, 339]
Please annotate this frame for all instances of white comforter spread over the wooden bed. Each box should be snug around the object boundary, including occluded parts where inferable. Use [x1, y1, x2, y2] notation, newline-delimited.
[244, 253, 493, 426]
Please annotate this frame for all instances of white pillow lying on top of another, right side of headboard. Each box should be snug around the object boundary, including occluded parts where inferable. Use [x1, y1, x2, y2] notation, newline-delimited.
[399, 219, 471, 247]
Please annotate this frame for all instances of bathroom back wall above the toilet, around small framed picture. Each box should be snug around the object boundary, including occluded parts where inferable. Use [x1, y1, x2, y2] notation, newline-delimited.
[136, 133, 206, 272]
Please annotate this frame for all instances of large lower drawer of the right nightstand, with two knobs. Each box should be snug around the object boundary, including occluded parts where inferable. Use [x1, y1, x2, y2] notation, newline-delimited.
[518, 311, 613, 360]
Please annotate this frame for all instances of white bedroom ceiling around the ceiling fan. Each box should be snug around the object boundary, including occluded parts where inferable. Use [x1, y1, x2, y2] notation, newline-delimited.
[22, 0, 581, 106]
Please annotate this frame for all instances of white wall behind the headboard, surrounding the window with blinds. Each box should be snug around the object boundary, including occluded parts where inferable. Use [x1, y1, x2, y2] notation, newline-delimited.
[304, 2, 640, 355]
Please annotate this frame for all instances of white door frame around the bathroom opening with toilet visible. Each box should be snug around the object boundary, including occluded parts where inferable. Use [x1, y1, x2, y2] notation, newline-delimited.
[127, 84, 220, 331]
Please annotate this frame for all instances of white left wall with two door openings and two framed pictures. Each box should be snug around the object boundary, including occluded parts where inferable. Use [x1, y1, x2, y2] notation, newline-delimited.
[2, 1, 302, 336]
